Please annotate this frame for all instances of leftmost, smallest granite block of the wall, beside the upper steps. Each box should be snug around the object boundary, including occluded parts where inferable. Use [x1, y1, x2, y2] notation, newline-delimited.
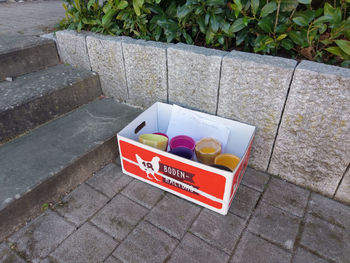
[56, 30, 91, 70]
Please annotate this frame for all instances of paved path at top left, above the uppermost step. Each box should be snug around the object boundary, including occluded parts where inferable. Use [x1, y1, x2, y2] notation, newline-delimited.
[0, 1, 64, 37]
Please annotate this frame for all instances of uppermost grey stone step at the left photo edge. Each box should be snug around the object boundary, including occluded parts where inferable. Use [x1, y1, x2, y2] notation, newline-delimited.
[0, 36, 59, 81]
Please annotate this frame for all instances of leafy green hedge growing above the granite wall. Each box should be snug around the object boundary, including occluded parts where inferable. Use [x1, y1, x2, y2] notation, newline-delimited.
[60, 0, 350, 67]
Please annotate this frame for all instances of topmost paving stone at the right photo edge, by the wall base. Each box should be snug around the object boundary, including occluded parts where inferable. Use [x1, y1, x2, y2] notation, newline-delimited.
[308, 193, 350, 230]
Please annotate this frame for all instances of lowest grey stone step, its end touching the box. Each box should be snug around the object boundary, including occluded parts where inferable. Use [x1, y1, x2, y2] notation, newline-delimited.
[0, 99, 140, 242]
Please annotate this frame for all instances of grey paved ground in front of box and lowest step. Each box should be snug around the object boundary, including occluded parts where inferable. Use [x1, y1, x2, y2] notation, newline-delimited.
[0, 164, 350, 263]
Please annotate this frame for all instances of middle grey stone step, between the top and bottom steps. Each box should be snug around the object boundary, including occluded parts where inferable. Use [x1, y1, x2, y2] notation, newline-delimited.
[0, 64, 101, 144]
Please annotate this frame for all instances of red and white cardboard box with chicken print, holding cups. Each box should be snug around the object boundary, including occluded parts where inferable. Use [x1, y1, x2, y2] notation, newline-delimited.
[118, 102, 255, 215]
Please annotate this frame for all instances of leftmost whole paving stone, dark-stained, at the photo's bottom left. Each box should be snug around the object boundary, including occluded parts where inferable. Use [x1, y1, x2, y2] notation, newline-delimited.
[9, 210, 75, 261]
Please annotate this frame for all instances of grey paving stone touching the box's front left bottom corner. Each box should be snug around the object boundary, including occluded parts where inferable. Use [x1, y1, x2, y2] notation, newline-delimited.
[86, 163, 132, 197]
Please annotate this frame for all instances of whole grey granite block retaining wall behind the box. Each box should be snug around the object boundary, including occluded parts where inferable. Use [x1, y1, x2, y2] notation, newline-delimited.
[56, 31, 350, 203]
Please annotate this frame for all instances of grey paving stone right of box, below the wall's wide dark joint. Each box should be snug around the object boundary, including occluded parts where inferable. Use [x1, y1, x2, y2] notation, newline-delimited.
[263, 178, 310, 217]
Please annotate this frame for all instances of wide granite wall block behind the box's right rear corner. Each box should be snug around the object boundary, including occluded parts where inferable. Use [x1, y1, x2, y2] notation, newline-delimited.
[218, 51, 297, 171]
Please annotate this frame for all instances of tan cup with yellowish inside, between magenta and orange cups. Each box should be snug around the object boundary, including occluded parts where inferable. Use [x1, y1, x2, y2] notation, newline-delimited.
[195, 138, 221, 165]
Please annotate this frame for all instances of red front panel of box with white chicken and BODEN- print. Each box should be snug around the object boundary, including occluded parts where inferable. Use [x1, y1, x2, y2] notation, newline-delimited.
[119, 140, 226, 209]
